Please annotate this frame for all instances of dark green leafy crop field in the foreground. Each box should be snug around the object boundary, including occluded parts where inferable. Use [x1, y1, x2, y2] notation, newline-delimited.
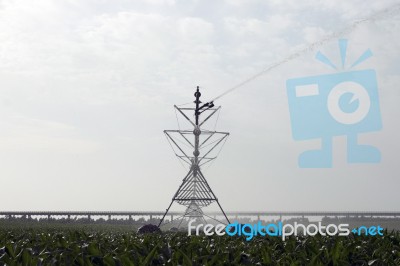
[0, 224, 400, 265]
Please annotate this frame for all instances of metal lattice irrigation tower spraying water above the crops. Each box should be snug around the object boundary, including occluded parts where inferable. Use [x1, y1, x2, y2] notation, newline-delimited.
[158, 86, 229, 227]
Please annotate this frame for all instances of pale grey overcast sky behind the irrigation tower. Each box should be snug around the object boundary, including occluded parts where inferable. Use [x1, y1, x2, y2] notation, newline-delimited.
[0, 0, 400, 211]
